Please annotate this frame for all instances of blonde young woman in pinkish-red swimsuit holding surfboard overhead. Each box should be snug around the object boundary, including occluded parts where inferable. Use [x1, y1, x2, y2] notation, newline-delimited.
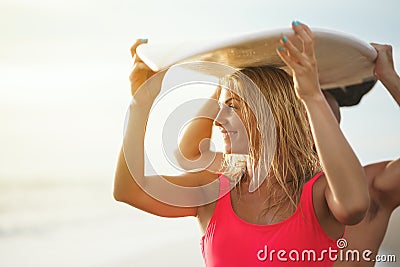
[114, 22, 369, 266]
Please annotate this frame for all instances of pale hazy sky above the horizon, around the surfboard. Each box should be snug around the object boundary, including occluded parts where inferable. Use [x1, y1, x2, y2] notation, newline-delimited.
[0, 0, 400, 184]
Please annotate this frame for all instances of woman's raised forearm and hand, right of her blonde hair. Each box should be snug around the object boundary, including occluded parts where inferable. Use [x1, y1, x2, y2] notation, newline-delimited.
[278, 23, 369, 225]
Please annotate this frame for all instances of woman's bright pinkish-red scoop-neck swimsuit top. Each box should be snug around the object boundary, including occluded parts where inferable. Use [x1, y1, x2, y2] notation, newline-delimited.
[201, 173, 338, 267]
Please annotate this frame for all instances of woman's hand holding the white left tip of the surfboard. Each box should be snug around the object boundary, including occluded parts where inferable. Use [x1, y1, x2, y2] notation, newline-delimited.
[129, 39, 155, 96]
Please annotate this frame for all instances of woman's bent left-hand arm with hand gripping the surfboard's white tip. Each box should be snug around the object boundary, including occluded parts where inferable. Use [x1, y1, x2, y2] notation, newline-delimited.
[114, 40, 216, 217]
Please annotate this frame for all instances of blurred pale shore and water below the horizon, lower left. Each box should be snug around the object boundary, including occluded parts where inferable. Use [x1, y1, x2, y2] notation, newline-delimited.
[0, 180, 203, 267]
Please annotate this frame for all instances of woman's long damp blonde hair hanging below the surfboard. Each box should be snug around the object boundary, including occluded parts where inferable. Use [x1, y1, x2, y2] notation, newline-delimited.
[221, 66, 321, 220]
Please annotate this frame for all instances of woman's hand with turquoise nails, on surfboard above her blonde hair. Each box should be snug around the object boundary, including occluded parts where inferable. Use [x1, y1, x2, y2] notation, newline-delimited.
[277, 21, 321, 100]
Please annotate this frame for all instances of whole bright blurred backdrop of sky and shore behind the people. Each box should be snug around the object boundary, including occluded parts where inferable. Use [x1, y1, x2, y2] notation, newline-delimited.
[0, 0, 400, 267]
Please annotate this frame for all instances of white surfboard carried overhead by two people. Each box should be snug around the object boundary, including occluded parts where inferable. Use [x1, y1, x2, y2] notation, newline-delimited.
[137, 28, 377, 106]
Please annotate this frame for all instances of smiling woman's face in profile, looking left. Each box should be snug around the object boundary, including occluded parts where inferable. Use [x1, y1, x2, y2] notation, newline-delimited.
[214, 89, 249, 154]
